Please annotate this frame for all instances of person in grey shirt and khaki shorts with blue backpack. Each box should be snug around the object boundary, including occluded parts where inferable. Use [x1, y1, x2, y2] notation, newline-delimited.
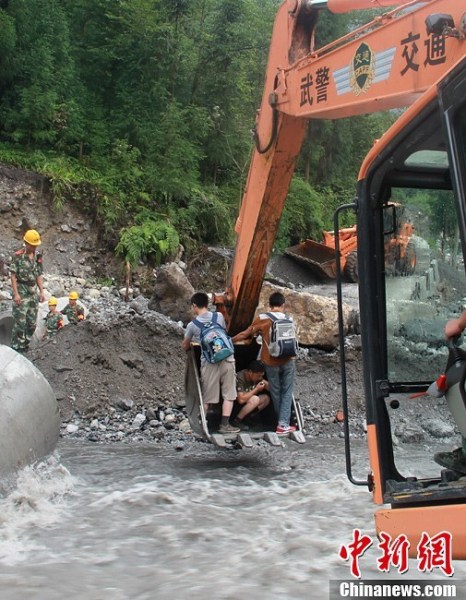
[181, 292, 240, 433]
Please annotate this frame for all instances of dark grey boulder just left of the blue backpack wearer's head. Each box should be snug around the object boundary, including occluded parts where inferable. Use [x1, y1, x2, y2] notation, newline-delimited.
[149, 263, 194, 323]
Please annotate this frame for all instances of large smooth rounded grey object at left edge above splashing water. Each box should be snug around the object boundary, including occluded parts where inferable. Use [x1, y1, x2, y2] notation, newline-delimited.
[0, 346, 60, 478]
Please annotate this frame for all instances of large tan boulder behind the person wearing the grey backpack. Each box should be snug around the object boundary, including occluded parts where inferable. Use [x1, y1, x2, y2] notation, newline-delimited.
[256, 281, 351, 350]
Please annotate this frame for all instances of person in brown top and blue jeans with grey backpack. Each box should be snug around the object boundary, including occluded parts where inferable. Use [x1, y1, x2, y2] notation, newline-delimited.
[233, 292, 297, 433]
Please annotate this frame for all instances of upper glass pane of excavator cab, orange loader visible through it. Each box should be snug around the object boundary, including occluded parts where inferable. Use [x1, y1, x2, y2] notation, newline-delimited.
[385, 188, 456, 385]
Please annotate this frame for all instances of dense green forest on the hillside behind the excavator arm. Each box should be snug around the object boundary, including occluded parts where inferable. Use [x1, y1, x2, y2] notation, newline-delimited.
[0, 0, 400, 263]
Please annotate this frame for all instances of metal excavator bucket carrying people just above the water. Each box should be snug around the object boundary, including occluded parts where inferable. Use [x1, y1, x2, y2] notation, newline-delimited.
[184, 346, 306, 448]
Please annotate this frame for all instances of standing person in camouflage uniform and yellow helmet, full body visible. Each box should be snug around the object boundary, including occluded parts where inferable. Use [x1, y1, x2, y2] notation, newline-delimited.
[10, 229, 45, 354]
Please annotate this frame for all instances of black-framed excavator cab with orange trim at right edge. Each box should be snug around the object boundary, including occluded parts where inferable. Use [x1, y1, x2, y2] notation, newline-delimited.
[343, 59, 466, 559]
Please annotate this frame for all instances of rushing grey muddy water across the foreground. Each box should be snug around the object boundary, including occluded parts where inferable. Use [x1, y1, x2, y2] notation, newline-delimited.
[0, 440, 466, 600]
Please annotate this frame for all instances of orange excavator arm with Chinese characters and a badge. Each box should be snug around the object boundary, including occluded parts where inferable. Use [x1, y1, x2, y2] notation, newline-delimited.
[222, 0, 466, 335]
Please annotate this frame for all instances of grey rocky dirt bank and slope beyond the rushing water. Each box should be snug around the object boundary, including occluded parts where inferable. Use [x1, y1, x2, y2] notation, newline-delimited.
[0, 164, 456, 446]
